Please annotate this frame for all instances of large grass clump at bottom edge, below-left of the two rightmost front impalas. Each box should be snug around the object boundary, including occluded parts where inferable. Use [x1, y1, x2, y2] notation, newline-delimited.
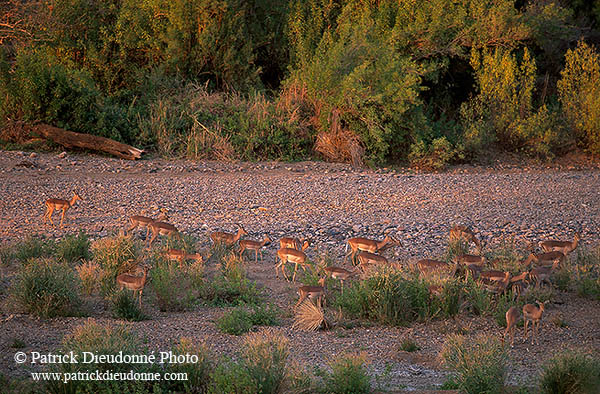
[440, 335, 507, 393]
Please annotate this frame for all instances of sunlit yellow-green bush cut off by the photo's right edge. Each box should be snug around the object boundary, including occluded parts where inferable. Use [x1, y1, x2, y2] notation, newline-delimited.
[557, 40, 600, 154]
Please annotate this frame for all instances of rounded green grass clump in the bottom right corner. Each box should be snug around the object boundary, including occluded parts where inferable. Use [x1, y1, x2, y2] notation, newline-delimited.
[539, 352, 600, 394]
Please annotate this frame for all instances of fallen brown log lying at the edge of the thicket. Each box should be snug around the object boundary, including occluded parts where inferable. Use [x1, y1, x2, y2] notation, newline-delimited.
[32, 123, 144, 160]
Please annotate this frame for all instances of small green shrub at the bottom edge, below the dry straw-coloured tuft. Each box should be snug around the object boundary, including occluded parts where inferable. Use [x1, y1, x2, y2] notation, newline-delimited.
[323, 355, 371, 394]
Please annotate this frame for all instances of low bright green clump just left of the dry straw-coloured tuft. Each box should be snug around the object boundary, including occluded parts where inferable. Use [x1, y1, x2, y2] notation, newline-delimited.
[217, 306, 279, 335]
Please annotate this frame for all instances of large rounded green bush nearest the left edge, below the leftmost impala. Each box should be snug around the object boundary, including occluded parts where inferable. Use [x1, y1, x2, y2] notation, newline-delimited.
[11, 259, 81, 317]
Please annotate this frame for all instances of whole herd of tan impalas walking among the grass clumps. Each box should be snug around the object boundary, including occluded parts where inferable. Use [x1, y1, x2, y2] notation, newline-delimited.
[44, 192, 581, 346]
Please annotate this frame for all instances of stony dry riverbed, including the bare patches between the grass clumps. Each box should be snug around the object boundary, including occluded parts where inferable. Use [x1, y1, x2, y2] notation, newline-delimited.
[0, 152, 600, 389]
